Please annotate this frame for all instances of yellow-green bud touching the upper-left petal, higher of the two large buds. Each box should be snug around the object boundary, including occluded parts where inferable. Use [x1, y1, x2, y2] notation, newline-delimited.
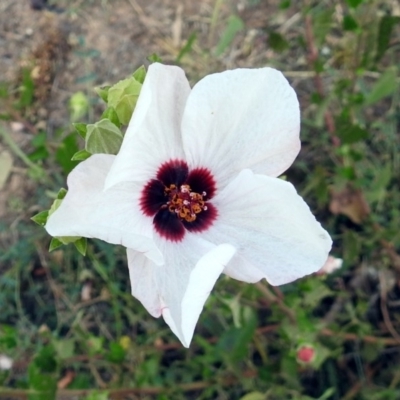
[108, 76, 142, 125]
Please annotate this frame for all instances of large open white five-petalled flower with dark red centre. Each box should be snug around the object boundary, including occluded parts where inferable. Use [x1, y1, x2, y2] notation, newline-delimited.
[46, 64, 331, 346]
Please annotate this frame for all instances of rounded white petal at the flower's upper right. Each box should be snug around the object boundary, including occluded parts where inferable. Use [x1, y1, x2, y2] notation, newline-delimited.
[182, 68, 300, 188]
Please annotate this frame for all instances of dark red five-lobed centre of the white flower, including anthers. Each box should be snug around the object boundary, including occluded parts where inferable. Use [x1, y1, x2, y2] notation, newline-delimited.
[140, 160, 217, 242]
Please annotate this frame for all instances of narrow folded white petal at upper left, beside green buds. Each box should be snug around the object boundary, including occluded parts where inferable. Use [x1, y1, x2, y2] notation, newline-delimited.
[106, 63, 190, 188]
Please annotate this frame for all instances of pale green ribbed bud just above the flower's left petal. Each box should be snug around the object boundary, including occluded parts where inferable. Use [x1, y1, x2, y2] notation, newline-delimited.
[85, 119, 123, 154]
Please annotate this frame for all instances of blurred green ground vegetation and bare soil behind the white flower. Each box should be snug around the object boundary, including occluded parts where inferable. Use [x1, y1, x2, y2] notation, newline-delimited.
[0, 0, 400, 400]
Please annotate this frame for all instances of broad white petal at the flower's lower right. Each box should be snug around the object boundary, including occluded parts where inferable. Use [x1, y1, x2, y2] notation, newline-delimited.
[208, 170, 332, 285]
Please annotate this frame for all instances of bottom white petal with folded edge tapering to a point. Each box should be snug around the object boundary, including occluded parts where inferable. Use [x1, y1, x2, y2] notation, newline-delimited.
[127, 238, 235, 347]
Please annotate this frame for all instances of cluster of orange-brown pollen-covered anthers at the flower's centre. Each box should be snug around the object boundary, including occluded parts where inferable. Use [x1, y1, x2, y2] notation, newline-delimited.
[165, 184, 207, 222]
